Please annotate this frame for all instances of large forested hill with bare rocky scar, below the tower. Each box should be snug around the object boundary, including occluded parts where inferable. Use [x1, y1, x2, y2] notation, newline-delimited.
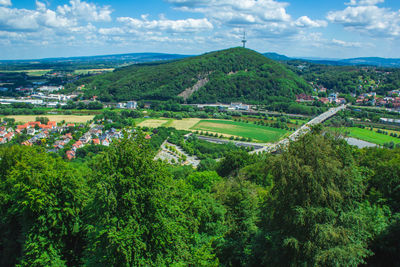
[69, 48, 311, 103]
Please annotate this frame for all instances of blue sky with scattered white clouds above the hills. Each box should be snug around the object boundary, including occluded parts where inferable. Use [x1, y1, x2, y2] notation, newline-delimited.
[0, 0, 400, 60]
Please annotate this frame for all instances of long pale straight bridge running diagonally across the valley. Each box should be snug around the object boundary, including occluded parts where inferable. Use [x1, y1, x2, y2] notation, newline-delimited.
[250, 105, 347, 154]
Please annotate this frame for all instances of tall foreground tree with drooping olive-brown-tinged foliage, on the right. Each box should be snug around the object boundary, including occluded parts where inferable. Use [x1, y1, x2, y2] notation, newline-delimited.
[263, 132, 387, 266]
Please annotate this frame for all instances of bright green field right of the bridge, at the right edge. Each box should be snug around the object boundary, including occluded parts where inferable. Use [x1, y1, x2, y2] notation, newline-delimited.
[340, 127, 400, 145]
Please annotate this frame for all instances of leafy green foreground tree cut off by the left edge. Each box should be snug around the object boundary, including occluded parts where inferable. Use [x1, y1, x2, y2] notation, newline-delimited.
[0, 146, 88, 266]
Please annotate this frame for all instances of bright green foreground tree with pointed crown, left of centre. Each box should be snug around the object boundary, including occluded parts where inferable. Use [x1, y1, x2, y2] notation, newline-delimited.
[85, 134, 222, 266]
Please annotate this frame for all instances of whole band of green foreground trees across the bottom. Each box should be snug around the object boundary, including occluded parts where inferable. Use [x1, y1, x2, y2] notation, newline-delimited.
[0, 128, 400, 266]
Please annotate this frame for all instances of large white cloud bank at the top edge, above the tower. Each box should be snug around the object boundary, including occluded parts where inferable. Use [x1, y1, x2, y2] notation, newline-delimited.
[167, 0, 327, 38]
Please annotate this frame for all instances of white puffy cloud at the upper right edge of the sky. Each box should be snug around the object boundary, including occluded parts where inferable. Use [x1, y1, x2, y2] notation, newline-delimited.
[327, 4, 400, 37]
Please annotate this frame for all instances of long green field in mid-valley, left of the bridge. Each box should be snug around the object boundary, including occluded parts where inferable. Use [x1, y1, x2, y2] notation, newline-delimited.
[190, 120, 290, 142]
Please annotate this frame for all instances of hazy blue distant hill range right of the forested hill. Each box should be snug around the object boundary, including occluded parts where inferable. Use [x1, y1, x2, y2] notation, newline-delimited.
[264, 53, 400, 68]
